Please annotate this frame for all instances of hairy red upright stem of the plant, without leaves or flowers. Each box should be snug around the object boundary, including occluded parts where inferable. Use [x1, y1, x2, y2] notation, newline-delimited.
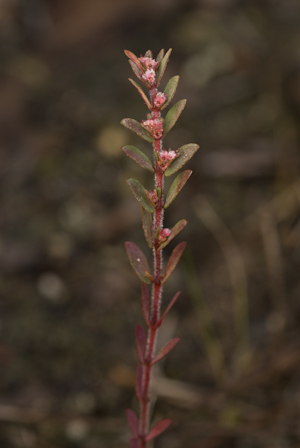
[139, 86, 164, 448]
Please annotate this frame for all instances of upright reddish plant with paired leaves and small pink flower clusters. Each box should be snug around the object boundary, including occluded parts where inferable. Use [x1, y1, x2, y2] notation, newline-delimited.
[121, 49, 199, 448]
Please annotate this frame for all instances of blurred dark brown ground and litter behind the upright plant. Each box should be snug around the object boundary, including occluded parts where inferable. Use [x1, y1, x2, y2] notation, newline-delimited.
[0, 0, 300, 448]
